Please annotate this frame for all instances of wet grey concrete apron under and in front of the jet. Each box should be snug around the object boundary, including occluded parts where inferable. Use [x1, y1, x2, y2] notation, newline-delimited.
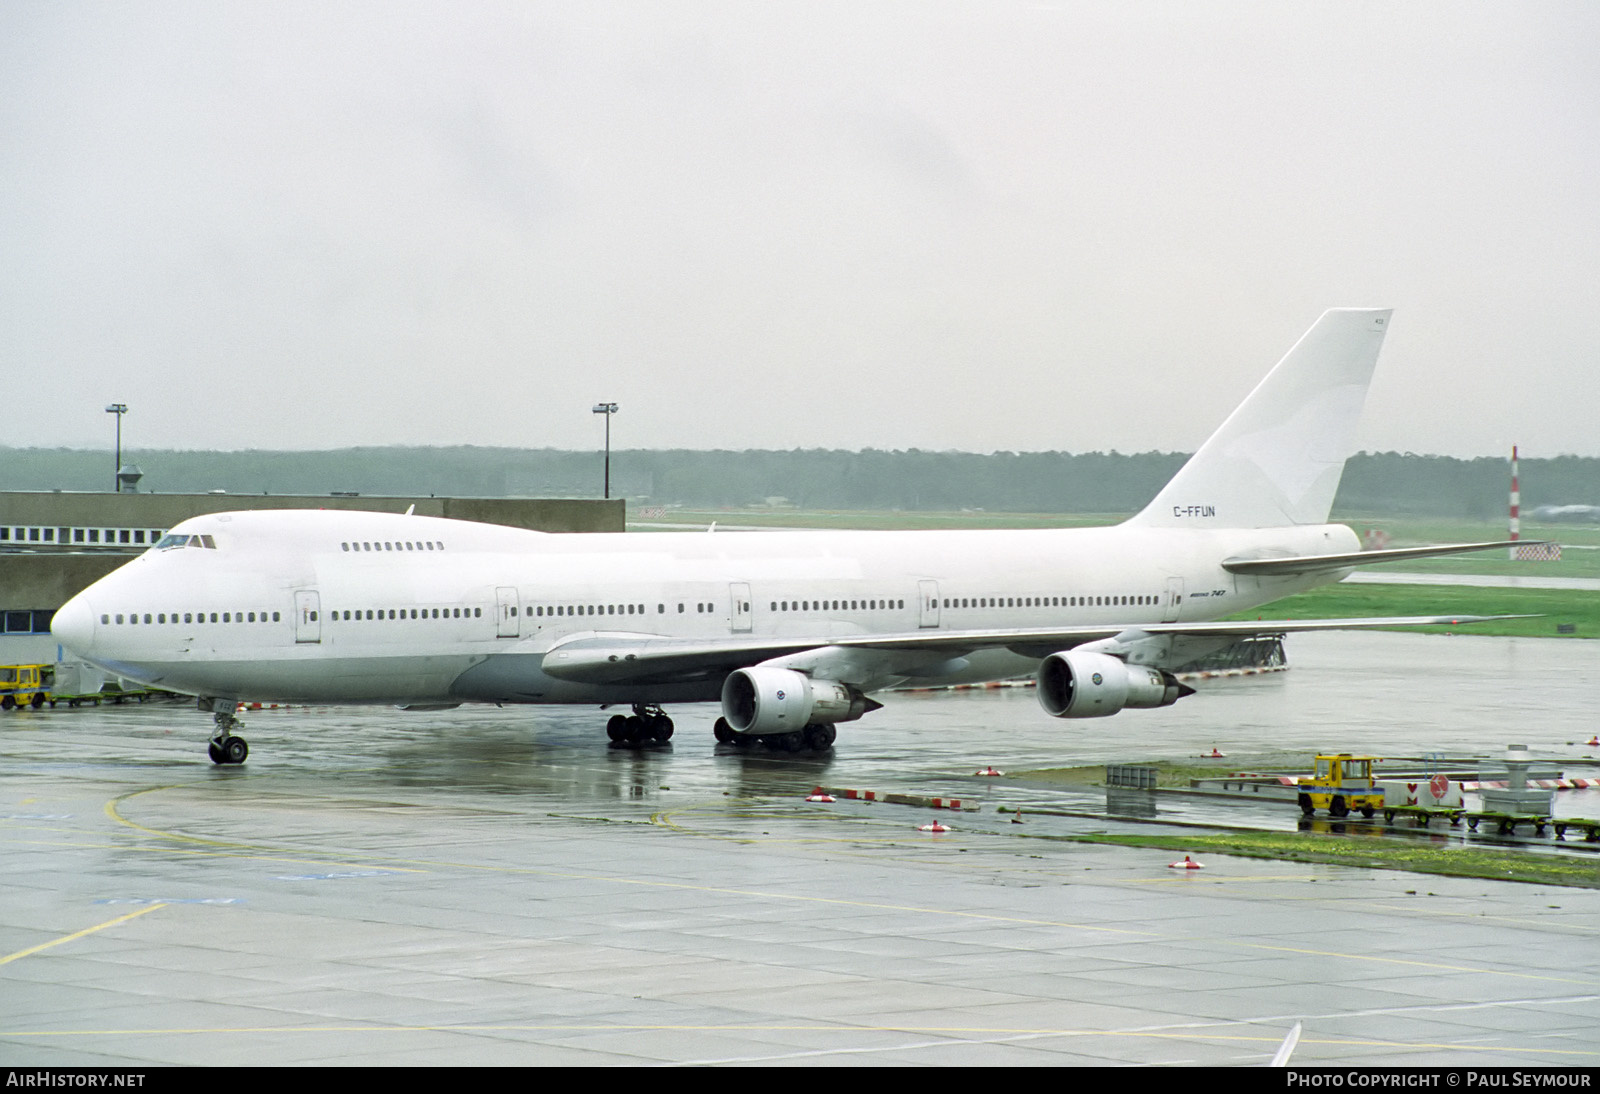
[0, 635, 1600, 1067]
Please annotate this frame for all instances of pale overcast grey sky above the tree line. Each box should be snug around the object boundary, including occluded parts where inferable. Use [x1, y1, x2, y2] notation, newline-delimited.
[0, 0, 1600, 456]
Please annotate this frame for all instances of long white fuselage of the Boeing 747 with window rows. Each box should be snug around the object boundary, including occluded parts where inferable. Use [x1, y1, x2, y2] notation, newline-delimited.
[54, 510, 1358, 704]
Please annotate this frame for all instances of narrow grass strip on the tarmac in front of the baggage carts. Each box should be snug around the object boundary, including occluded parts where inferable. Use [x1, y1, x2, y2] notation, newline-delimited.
[1035, 832, 1600, 889]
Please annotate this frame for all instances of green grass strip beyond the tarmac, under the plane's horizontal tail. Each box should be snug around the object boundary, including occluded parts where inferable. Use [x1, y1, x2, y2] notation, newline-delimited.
[1232, 584, 1600, 638]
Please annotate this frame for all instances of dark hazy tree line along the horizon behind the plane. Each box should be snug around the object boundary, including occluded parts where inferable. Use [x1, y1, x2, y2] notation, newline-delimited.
[0, 446, 1600, 520]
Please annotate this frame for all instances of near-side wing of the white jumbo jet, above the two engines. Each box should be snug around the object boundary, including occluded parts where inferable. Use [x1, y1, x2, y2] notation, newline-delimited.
[542, 616, 1514, 685]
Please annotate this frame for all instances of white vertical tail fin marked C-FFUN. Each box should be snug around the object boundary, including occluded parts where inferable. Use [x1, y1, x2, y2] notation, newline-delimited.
[1128, 309, 1392, 528]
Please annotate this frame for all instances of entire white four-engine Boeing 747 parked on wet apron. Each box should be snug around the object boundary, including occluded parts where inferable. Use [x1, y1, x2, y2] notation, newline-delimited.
[53, 309, 1506, 763]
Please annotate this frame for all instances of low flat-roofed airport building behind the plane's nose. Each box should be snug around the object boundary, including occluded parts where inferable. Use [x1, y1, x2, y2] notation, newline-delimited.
[0, 491, 624, 665]
